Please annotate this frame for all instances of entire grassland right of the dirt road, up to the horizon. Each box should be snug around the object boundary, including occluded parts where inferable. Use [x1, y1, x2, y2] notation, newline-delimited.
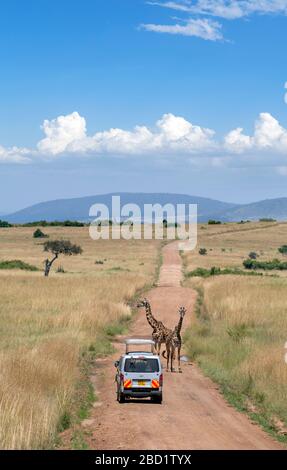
[183, 222, 287, 440]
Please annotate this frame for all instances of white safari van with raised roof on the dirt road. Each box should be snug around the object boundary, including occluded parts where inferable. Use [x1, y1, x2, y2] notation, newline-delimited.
[115, 339, 163, 403]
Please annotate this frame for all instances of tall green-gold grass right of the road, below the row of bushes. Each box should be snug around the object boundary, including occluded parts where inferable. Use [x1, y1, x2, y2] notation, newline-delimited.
[186, 276, 287, 432]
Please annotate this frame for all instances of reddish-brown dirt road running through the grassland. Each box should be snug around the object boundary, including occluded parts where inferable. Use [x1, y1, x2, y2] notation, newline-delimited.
[83, 243, 282, 450]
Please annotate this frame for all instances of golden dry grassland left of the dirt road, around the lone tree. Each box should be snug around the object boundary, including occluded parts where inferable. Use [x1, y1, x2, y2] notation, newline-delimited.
[0, 227, 160, 449]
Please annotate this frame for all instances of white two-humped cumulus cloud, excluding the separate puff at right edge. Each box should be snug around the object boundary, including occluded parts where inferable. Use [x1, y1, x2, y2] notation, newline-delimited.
[35, 112, 215, 156]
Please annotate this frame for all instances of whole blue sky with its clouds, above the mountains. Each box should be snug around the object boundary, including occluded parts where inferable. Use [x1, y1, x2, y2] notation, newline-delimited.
[0, 0, 287, 213]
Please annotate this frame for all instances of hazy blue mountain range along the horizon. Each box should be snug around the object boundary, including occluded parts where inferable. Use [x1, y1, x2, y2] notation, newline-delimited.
[5, 193, 287, 224]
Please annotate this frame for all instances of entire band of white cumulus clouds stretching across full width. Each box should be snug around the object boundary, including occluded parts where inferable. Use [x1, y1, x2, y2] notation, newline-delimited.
[0, 112, 287, 175]
